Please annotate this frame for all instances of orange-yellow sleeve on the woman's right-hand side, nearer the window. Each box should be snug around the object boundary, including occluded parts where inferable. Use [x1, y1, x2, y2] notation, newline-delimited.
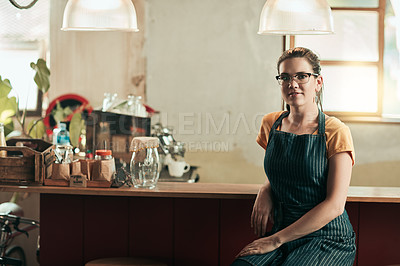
[325, 117, 355, 165]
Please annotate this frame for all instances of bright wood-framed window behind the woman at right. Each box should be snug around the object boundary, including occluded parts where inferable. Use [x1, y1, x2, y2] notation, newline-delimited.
[290, 0, 400, 122]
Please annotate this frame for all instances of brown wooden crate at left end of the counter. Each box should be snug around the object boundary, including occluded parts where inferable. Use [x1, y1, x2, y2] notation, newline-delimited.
[0, 139, 55, 185]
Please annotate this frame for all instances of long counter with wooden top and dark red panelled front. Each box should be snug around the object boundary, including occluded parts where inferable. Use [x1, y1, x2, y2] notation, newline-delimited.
[0, 183, 400, 266]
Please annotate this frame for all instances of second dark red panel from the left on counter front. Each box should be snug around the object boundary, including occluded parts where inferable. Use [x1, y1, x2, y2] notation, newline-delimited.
[83, 196, 129, 263]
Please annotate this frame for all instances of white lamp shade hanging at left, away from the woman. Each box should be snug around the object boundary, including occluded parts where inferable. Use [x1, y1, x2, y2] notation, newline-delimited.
[61, 0, 139, 31]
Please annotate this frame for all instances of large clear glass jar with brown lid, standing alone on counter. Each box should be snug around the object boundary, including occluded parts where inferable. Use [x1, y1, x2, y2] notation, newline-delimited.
[129, 137, 161, 189]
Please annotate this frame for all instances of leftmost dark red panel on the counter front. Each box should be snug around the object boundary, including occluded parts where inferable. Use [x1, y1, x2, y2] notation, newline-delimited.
[40, 194, 84, 266]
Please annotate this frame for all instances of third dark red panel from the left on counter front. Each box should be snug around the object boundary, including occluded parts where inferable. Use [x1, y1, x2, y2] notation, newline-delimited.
[129, 198, 174, 265]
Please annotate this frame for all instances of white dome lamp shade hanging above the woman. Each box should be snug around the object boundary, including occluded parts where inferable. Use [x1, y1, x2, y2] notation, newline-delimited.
[258, 0, 333, 35]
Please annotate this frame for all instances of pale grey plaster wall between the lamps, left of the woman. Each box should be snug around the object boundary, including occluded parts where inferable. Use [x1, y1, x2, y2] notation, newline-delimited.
[145, 0, 282, 183]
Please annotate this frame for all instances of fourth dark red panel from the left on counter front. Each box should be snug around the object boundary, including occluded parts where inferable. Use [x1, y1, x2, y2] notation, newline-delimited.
[174, 199, 219, 266]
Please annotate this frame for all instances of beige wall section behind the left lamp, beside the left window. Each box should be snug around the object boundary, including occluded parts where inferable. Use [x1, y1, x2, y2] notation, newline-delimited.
[49, 0, 145, 107]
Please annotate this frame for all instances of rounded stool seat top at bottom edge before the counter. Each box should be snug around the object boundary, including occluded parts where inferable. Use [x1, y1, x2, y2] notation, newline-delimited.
[85, 257, 168, 266]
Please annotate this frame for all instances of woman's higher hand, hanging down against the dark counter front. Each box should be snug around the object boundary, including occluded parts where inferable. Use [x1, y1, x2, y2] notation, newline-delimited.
[251, 181, 272, 237]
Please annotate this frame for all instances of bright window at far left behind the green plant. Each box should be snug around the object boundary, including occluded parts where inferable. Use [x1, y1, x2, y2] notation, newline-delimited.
[0, 0, 50, 115]
